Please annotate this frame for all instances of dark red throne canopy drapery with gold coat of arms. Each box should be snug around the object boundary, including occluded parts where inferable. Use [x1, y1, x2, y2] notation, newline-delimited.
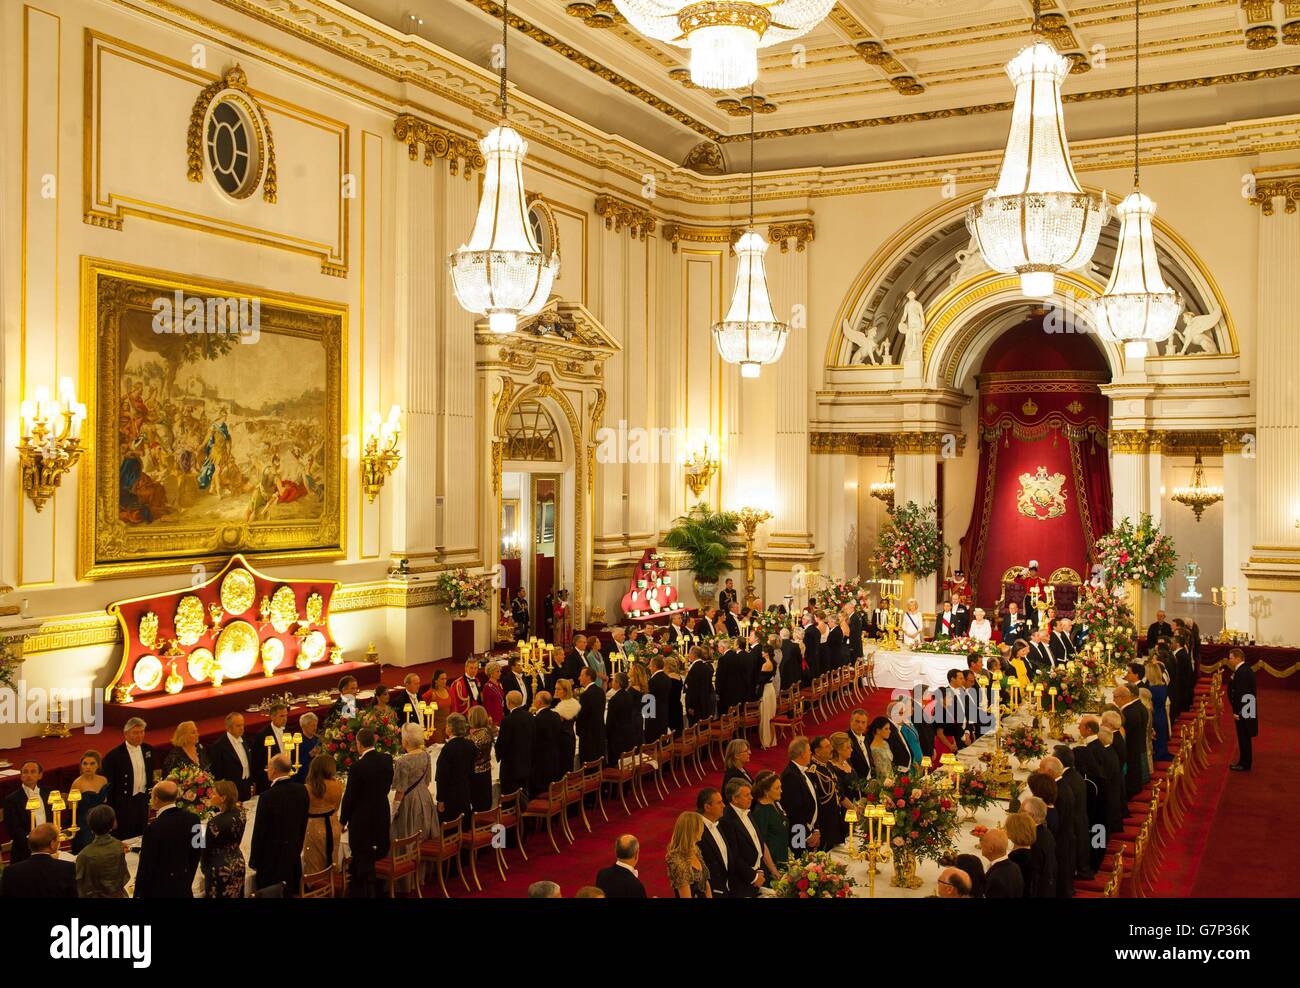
[961, 316, 1112, 608]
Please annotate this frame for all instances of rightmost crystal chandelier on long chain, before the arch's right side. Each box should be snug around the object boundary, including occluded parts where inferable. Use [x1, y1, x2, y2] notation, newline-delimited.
[1086, 0, 1180, 348]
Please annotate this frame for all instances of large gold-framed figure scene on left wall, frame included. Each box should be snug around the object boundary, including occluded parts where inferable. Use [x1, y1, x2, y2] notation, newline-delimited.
[79, 259, 345, 577]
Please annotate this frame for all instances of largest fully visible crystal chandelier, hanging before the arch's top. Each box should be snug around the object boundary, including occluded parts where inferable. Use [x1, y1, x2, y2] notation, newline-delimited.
[966, 0, 1106, 298]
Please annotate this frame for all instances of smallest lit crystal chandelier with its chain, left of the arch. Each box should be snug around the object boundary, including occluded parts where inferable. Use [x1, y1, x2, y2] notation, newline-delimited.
[714, 91, 790, 377]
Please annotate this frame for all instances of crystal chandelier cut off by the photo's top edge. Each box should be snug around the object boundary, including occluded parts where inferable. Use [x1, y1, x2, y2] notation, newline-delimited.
[614, 0, 835, 90]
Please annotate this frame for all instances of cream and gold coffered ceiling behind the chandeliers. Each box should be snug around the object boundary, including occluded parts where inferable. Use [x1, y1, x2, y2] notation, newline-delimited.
[348, 0, 1300, 170]
